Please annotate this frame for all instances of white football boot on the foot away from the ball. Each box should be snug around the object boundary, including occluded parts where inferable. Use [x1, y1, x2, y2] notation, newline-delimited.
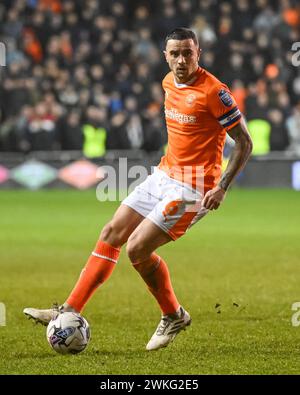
[146, 307, 192, 351]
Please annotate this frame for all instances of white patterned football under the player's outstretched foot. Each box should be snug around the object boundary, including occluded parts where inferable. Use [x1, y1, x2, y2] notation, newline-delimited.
[47, 312, 91, 354]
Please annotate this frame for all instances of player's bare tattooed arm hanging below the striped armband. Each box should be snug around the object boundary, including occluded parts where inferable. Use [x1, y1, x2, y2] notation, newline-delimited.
[202, 117, 252, 210]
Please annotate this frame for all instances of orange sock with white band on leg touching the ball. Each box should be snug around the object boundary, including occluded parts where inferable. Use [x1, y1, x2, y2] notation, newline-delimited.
[66, 240, 120, 312]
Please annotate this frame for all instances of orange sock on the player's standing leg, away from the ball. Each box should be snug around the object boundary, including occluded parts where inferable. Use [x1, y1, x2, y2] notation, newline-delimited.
[134, 253, 180, 315]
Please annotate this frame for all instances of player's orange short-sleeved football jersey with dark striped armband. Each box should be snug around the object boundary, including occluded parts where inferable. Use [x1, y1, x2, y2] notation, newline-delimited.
[159, 67, 241, 191]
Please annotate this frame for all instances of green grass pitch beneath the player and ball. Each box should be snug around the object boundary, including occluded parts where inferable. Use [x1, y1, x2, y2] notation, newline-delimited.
[0, 189, 300, 374]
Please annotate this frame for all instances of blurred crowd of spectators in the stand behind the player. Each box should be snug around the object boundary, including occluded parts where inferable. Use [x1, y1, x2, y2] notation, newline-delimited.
[0, 0, 300, 156]
